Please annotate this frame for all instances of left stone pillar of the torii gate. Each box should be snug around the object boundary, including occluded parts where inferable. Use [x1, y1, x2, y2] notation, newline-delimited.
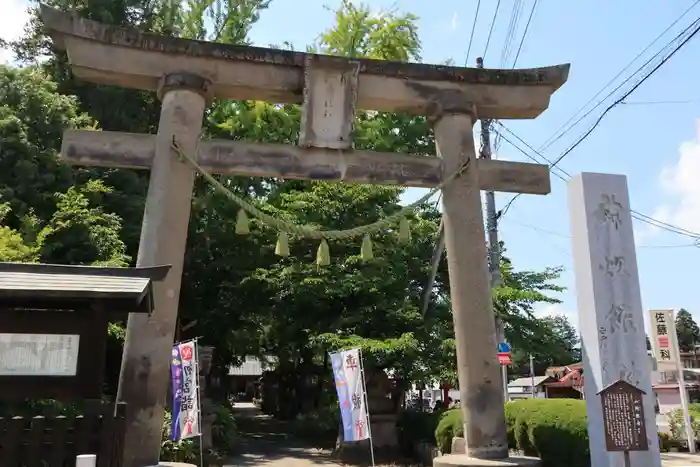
[117, 73, 208, 467]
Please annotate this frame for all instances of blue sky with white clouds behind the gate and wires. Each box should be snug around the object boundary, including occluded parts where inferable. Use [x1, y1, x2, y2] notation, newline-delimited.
[0, 0, 700, 334]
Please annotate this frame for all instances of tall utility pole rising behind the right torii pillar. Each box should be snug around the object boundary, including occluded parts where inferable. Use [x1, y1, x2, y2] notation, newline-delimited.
[476, 57, 508, 402]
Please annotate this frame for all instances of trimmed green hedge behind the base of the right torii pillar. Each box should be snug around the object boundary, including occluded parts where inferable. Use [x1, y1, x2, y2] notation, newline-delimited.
[435, 399, 590, 467]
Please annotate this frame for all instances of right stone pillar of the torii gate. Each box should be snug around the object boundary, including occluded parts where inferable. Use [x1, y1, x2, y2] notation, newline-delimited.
[434, 114, 508, 459]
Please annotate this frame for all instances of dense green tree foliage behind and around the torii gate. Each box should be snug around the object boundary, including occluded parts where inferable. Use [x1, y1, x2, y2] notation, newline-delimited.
[0, 0, 576, 415]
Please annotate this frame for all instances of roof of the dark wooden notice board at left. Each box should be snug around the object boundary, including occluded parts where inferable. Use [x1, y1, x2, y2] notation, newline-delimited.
[0, 262, 170, 312]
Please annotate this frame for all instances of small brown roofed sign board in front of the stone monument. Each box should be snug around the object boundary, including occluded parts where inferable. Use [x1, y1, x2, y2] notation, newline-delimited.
[598, 380, 649, 451]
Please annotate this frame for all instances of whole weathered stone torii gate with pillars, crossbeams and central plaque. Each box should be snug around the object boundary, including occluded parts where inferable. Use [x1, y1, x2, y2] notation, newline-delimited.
[41, 5, 569, 467]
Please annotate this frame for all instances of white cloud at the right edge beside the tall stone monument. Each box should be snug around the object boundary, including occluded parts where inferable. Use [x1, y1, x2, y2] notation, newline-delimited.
[641, 121, 700, 237]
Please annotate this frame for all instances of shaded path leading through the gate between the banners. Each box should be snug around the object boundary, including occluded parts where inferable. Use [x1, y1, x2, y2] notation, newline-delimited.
[224, 402, 340, 467]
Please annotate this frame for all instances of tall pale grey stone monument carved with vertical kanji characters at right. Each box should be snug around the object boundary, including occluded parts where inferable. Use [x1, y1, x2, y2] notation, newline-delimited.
[569, 173, 661, 467]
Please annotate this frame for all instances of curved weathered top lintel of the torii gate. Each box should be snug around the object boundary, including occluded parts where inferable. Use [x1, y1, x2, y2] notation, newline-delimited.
[41, 4, 569, 119]
